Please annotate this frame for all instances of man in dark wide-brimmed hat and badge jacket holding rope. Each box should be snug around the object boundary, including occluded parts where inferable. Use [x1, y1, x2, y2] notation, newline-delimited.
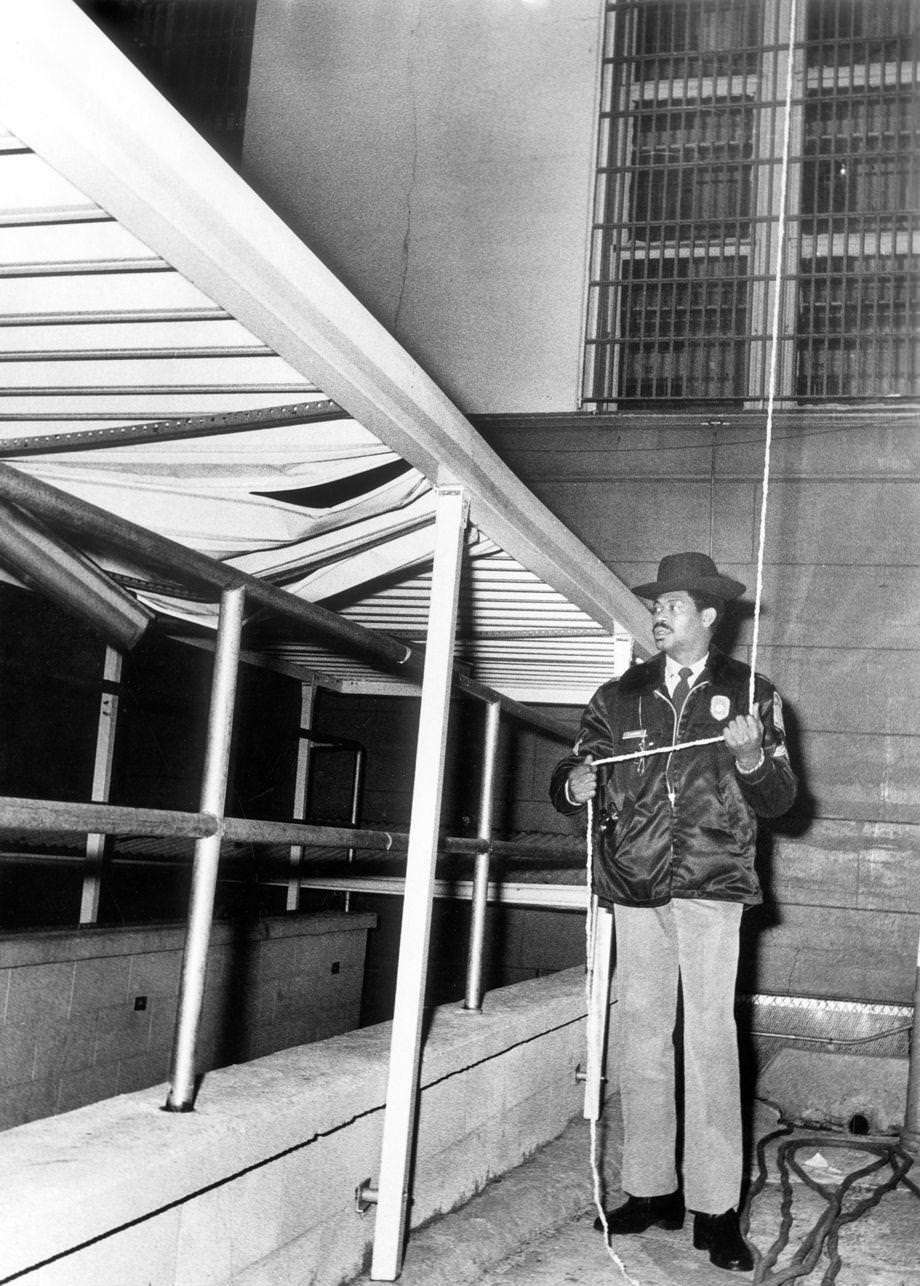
[551, 553, 796, 1271]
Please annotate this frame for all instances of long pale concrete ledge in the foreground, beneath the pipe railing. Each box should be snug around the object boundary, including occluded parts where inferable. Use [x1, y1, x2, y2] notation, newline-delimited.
[0, 968, 612, 1286]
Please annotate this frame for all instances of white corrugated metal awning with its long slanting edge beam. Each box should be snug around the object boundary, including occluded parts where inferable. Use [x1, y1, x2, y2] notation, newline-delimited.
[0, 0, 650, 703]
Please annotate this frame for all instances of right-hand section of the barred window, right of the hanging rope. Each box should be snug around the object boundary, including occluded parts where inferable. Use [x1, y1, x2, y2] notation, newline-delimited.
[795, 0, 920, 399]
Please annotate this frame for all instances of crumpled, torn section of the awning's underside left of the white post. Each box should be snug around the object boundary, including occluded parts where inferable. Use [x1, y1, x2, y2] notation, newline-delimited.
[6, 419, 434, 624]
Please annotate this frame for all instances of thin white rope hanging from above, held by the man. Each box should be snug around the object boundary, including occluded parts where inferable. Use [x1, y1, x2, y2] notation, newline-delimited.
[585, 0, 798, 1286]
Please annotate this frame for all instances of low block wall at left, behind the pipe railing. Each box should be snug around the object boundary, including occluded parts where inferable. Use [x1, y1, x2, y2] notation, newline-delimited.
[0, 913, 376, 1128]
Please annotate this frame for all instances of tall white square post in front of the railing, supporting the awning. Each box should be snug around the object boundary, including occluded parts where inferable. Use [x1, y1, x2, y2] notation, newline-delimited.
[371, 486, 468, 1281]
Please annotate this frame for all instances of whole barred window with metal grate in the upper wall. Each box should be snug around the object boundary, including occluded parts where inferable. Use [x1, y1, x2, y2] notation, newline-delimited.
[583, 0, 920, 409]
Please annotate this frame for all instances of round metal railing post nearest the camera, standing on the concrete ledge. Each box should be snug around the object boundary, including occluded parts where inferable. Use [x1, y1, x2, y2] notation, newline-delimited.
[166, 588, 244, 1112]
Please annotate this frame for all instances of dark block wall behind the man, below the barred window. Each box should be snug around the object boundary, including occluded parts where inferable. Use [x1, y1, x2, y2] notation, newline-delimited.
[479, 406, 920, 1003]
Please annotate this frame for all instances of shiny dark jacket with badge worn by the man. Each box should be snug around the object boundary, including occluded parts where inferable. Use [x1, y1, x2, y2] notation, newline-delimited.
[549, 649, 796, 907]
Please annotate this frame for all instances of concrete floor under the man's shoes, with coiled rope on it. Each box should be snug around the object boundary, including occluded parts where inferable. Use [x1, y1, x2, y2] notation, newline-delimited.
[355, 1054, 920, 1286]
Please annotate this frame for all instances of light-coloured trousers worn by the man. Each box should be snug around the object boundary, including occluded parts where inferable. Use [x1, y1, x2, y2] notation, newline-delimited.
[614, 898, 742, 1214]
